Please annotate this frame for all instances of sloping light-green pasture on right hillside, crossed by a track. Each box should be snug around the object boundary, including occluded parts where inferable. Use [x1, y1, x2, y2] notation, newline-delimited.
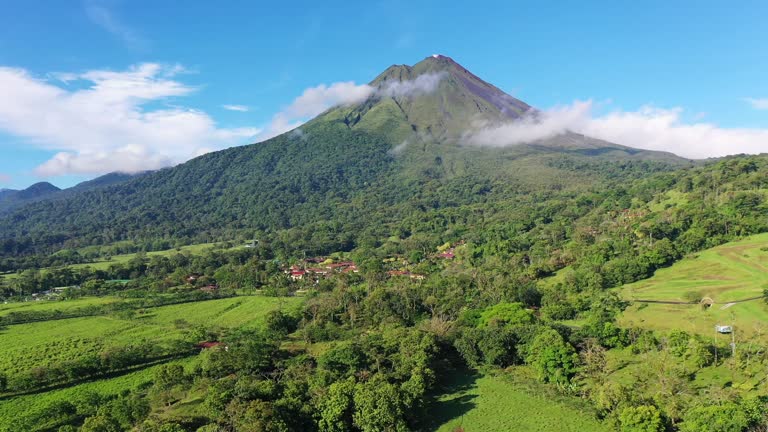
[620, 234, 768, 336]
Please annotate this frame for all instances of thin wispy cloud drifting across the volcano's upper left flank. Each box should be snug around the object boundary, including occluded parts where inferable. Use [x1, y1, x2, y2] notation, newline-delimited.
[258, 73, 445, 141]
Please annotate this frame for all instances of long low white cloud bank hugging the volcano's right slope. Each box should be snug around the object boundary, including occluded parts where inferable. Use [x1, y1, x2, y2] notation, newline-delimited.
[465, 101, 768, 158]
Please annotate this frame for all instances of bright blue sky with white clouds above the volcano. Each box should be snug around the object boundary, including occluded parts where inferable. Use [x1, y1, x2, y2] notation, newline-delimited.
[0, 0, 768, 188]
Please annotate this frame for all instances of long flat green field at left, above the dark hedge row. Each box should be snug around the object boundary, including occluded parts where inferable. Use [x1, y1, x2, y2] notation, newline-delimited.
[0, 296, 301, 375]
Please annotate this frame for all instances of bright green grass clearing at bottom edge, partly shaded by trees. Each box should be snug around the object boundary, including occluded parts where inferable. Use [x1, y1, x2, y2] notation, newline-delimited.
[430, 368, 610, 432]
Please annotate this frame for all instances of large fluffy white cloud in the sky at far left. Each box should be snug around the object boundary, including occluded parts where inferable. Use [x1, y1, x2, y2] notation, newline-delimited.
[0, 63, 260, 176]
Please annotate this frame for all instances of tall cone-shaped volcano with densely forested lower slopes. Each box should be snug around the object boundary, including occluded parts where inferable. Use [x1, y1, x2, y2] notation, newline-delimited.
[0, 56, 690, 256]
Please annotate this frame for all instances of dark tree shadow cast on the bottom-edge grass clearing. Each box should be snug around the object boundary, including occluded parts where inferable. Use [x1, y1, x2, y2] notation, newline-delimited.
[425, 370, 480, 430]
